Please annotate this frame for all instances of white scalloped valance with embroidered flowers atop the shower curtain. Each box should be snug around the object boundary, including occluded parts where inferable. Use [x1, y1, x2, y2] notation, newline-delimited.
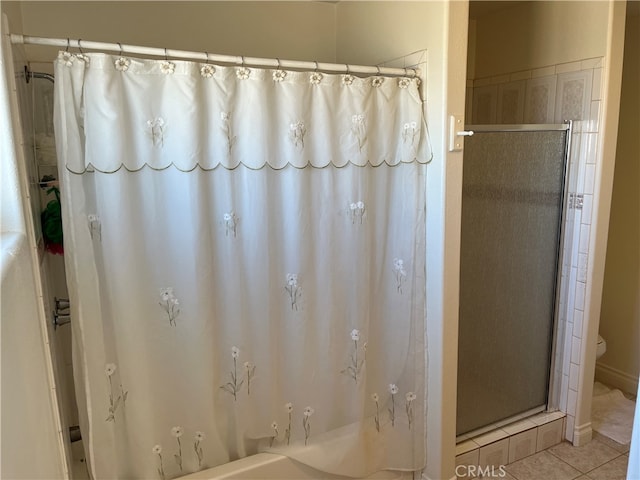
[57, 52, 431, 173]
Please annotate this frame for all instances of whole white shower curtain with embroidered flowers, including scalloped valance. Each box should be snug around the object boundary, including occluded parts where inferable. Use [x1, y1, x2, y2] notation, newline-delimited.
[55, 52, 431, 479]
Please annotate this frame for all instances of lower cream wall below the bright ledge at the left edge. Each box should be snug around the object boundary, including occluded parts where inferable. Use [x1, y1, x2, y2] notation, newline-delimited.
[0, 242, 65, 479]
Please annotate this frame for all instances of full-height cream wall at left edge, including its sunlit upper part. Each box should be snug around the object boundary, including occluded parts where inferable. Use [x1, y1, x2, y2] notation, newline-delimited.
[0, 13, 66, 479]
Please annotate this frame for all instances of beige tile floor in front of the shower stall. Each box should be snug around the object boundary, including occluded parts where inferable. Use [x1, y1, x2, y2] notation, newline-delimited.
[503, 434, 629, 480]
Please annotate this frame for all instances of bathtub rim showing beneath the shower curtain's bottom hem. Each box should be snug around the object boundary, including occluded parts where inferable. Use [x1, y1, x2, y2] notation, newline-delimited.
[179, 453, 414, 480]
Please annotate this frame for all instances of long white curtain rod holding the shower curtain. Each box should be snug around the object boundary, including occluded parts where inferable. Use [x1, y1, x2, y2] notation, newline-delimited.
[11, 34, 420, 77]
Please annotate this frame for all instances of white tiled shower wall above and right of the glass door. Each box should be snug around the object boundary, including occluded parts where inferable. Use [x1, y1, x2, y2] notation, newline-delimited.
[466, 57, 604, 441]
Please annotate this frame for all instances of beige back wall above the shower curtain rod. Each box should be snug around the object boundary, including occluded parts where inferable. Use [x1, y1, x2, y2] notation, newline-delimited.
[13, 1, 336, 73]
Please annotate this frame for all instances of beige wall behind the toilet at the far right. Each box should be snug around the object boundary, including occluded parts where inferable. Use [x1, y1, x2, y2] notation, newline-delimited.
[596, 8, 640, 394]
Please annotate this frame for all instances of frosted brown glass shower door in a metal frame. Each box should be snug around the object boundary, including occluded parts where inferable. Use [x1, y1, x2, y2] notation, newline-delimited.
[456, 125, 568, 435]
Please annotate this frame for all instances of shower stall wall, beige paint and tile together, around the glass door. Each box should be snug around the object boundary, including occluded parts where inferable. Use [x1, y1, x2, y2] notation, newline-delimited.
[467, 1, 617, 443]
